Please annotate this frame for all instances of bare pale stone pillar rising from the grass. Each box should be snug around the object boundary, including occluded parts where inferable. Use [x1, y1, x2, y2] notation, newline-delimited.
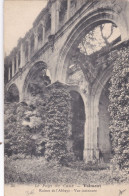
[84, 91, 102, 163]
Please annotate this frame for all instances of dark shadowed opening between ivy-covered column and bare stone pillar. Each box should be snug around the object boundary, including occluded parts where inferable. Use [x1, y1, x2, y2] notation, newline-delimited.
[70, 91, 85, 160]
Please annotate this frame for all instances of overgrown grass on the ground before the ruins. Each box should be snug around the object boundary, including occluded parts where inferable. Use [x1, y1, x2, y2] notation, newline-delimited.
[5, 157, 129, 185]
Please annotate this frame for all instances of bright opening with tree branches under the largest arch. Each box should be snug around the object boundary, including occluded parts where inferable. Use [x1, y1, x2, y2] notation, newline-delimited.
[78, 22, 121, 55]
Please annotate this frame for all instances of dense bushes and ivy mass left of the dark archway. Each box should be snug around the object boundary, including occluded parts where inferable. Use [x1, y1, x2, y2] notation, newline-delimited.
[5, 80, 71, 162]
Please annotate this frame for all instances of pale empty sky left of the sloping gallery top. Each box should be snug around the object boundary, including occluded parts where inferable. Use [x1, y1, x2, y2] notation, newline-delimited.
[4, 0, 47, 55]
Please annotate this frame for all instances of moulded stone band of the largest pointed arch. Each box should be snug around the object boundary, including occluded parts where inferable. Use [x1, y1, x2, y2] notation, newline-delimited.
[56, 8, 125, 82]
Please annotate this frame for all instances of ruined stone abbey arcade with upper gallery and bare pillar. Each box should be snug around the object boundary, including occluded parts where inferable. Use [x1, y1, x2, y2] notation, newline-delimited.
[5, 0, 129, 162]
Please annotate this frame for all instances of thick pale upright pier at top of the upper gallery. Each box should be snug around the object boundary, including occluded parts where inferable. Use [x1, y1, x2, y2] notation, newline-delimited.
[51, 1, 59, 35]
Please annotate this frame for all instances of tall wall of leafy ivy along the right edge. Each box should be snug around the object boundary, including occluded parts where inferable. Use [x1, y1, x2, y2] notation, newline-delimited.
[109, 47, 129, 169]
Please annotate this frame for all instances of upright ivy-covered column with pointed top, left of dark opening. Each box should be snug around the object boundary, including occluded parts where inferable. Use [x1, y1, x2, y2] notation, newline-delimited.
[45, 82, 71, 163]
